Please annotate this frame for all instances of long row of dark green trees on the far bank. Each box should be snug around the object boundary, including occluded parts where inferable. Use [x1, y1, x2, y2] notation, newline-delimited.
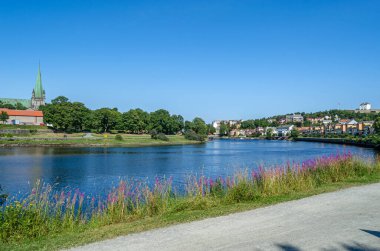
[40, 96, 213, 137]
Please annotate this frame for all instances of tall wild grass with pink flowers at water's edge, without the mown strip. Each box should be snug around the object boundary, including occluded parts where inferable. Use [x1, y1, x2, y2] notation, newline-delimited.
[0, 154, 380, 243]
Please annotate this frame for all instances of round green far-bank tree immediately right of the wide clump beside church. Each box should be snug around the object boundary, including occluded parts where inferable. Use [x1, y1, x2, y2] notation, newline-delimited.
[93, 108, 122, 133]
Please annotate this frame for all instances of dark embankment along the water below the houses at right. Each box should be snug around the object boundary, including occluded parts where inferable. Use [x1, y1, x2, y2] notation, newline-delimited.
[294, 137, 380, 149]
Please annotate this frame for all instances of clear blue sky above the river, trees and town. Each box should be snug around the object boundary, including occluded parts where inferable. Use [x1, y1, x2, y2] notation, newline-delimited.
[0, 0, 380, 122]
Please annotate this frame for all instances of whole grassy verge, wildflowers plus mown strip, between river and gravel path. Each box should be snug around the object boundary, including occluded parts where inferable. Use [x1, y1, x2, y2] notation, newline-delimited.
[0, 154, 380, 250]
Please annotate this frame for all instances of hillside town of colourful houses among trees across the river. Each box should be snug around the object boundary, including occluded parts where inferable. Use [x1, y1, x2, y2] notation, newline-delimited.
[212, 102, 380, 137]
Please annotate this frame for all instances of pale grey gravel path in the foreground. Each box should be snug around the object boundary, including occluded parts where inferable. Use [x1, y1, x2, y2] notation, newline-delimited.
[72, 183, 380, 251]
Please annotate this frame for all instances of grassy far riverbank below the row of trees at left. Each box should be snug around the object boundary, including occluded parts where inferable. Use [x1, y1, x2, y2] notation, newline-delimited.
[0, 133, 202, 147]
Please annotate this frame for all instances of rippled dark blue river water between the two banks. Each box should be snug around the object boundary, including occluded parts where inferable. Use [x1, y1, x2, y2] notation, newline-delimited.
[0, 140, 377, 194]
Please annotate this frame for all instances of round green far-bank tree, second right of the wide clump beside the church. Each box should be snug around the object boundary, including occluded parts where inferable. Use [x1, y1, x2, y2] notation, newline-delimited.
[122, 108, 149, 133]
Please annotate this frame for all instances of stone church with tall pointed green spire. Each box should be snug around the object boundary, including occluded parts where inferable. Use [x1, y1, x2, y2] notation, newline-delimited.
[0, 66, 45, 110]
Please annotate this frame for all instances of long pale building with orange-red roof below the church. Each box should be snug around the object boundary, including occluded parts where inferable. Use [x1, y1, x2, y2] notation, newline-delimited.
[0, 108, 44, 125]
